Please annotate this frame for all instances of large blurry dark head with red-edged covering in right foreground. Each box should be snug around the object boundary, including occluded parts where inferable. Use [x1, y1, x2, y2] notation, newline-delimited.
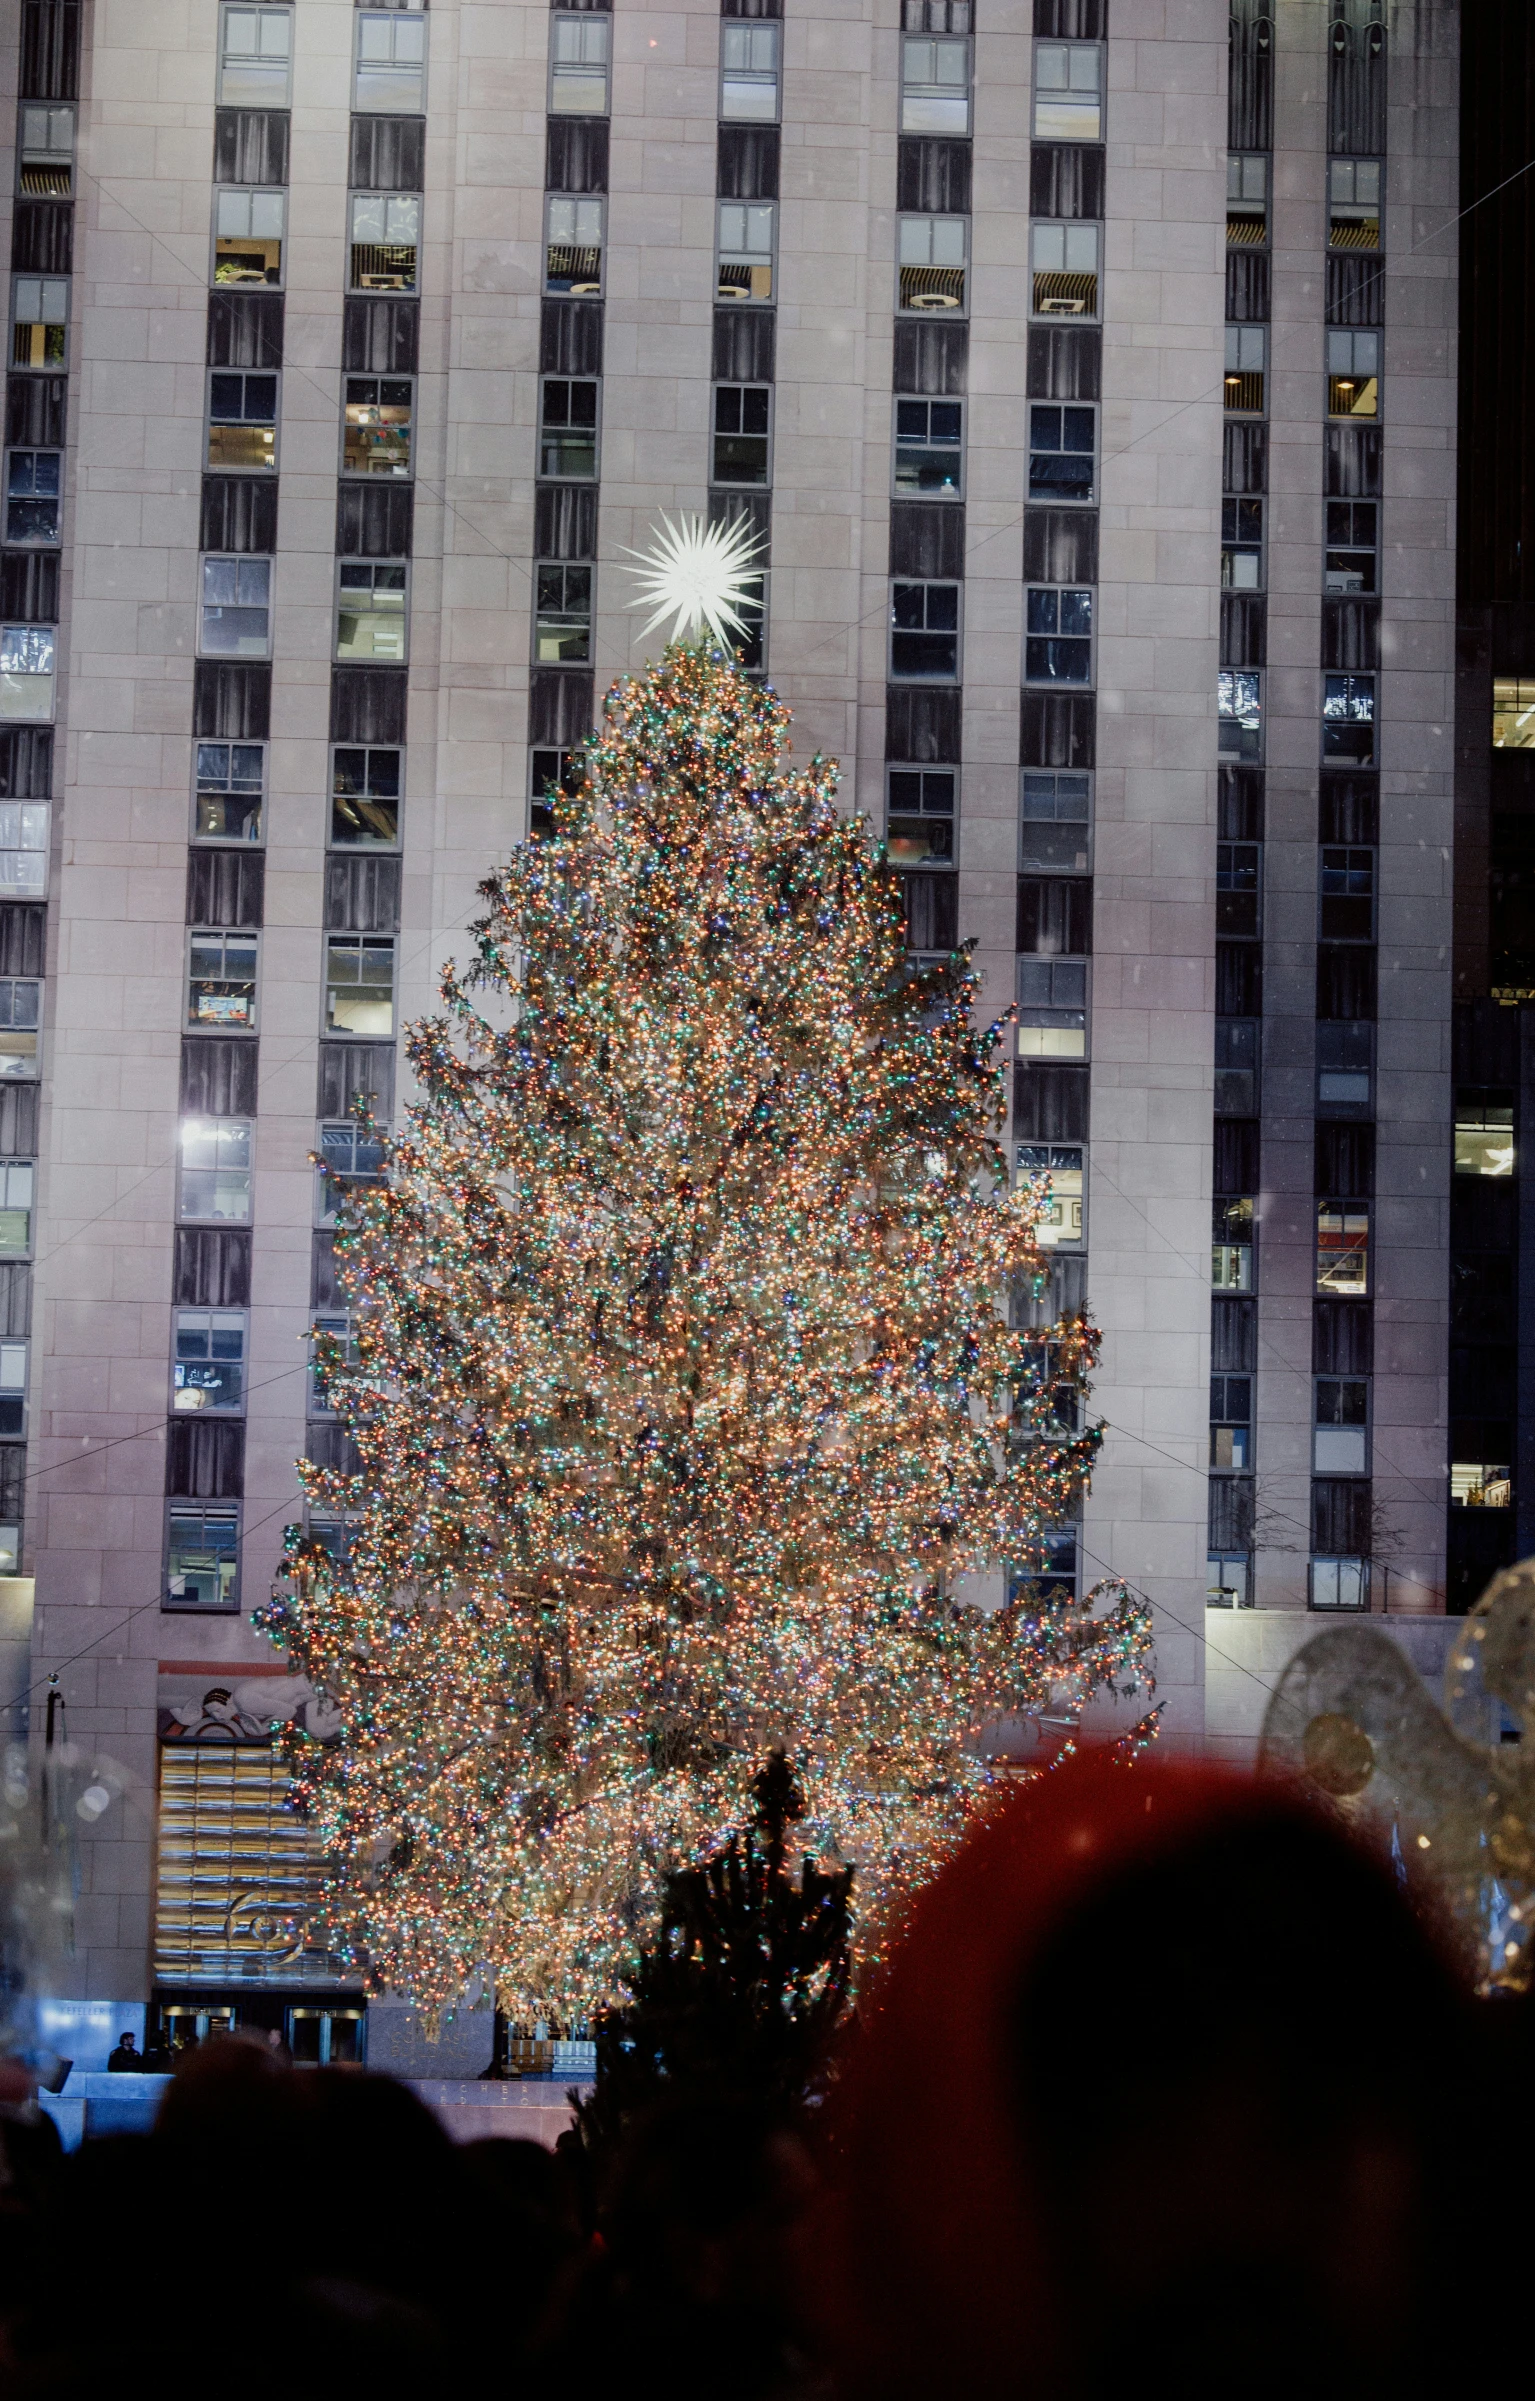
[829, 1762, 1477, 2401]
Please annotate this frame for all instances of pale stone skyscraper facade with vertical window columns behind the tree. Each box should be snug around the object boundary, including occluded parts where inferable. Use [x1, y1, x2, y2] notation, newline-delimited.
[0, 0, 1460, 2058]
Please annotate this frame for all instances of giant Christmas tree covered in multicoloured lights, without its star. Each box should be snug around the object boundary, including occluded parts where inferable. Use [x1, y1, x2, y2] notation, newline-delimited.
[264, 535, 1148, 2024]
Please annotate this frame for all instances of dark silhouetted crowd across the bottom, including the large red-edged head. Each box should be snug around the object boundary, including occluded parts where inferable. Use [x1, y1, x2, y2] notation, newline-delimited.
[0, 1762, 1528, 2401]
